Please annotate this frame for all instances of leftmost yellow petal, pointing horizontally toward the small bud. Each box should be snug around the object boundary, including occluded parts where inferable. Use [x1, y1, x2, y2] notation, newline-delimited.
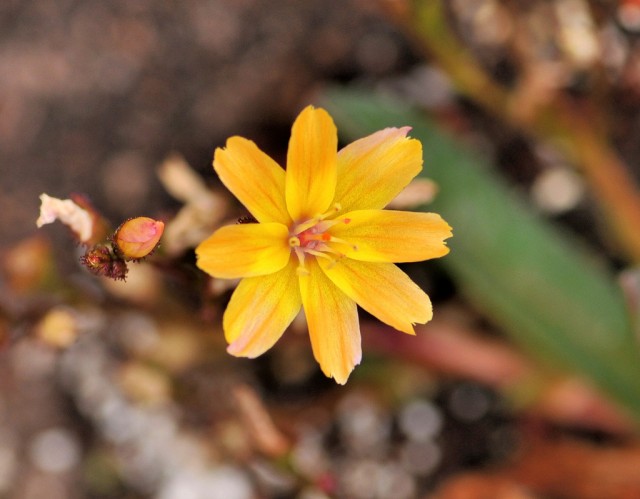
[196, 222, 291, 279]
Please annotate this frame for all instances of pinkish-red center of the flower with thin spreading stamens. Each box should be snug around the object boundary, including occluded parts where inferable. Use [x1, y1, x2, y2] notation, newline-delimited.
[289, 203, 356, 275]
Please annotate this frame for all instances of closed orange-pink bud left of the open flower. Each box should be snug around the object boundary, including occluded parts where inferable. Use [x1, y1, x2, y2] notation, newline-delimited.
[113, 217, 164, 260]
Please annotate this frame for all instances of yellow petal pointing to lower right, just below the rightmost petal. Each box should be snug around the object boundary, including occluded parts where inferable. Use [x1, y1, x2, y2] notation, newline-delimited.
[320, 258, 433, 334]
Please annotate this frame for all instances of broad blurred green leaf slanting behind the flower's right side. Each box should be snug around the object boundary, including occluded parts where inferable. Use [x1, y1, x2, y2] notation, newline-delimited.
[323, 89, 640, 419]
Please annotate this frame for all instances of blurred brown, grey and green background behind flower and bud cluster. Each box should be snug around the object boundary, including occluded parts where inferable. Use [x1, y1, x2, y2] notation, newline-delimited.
[0, 0, 640, 499]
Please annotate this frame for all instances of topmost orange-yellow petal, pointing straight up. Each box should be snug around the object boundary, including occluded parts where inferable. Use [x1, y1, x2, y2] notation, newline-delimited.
[286, 106, 338, 221]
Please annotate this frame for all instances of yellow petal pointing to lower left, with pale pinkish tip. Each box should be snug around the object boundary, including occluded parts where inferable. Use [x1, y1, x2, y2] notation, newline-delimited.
[222, 259, 302, 358]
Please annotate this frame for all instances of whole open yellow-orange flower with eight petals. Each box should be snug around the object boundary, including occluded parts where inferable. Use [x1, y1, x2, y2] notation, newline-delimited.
[196, 106, 451, 384]
